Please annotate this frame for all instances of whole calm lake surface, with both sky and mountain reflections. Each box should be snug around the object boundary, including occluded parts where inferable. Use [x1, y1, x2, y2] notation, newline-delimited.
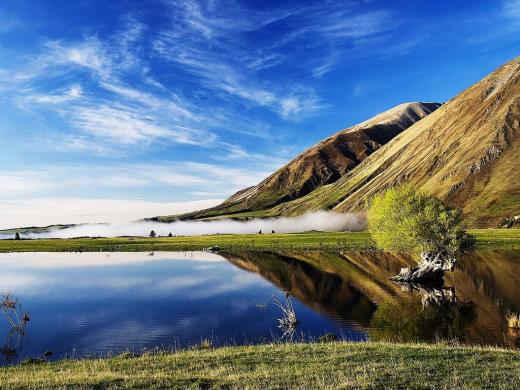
[0, 251, 520, 364]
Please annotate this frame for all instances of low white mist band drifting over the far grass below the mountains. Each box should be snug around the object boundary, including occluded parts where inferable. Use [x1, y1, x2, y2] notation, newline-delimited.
[16, 211, 366, 238]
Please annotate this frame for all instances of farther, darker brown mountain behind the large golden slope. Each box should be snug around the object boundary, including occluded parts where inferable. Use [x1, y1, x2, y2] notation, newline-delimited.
[157, 103, 440, 221]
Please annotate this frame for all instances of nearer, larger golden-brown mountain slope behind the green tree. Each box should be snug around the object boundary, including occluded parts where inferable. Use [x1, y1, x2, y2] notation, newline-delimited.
[271, 57, 520, 226]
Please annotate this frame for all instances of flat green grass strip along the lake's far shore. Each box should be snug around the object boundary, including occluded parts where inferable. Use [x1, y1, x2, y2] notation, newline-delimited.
[0, 229, 520, 252]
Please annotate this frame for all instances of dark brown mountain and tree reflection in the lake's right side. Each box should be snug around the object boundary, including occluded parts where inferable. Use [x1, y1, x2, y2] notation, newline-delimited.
[225, 251, 520, 346]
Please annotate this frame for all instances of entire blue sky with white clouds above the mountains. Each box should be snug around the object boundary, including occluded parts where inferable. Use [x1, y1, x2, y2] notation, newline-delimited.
[0, 0, 520, 227]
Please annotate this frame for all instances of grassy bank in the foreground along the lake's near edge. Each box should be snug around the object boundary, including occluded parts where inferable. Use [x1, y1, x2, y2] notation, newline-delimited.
[0, 342, 520, 389]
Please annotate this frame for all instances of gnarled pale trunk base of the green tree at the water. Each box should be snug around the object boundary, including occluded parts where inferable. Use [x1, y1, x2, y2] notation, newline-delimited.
[391, 253, 457, 283]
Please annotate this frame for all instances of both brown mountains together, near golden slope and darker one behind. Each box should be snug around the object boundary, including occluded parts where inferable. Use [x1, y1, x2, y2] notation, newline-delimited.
[155, 57, 520, 227]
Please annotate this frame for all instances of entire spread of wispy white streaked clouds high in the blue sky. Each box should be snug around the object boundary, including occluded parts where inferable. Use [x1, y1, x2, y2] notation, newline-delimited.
[0, 0, 406, 159]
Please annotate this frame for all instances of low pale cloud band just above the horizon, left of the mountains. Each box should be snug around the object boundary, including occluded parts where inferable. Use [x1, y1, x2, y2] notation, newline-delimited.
[0, 161, 278, 200]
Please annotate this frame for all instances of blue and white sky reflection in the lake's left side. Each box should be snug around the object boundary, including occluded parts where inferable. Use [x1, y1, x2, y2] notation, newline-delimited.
[0, 252, 350, 363]
